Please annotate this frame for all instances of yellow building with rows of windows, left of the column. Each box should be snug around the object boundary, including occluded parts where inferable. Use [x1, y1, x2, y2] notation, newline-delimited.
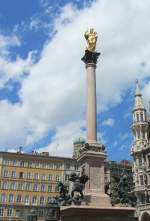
[0, 152, 78, 221]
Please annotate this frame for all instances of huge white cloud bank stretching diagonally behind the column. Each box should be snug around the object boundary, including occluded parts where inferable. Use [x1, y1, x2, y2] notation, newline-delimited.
[0, 0, 150, 155]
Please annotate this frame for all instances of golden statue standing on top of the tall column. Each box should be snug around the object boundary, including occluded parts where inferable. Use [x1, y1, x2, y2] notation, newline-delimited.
[84, 28, 98, 52]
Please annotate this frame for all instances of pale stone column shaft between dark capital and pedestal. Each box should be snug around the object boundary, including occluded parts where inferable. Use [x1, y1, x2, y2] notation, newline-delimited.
[86, 63, 97, 143]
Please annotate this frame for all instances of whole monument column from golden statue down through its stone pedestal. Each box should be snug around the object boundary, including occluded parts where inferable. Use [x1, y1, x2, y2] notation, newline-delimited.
[77, 28, 110, 207]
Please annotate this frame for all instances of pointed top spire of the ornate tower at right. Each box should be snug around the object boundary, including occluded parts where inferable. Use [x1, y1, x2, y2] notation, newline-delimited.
[134, 80, 145, 110]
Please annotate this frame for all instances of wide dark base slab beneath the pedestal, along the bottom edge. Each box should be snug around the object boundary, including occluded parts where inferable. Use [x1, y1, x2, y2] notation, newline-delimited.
[61, 206, 137, 221]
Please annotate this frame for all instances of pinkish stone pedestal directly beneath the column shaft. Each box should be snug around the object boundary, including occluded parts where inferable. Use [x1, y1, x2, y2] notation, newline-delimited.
[78, 147, 111, 207]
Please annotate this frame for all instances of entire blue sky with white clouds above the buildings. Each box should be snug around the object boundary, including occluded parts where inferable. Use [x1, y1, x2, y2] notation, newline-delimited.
[0, 0, 150, 160]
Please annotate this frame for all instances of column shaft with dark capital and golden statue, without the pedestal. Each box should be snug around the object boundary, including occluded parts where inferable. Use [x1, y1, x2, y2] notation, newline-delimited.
[82, 28, 100, 143]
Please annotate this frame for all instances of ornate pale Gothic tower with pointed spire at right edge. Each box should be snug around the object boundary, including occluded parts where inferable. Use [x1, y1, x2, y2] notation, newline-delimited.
[131, 81, 150, 221]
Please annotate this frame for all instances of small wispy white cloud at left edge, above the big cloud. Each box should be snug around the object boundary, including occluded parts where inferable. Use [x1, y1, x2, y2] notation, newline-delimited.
[0, 34, 33, 88]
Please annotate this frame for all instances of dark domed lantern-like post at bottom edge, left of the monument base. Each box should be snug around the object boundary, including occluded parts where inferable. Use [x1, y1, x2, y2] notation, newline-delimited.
[45, 198, 60, 221]
